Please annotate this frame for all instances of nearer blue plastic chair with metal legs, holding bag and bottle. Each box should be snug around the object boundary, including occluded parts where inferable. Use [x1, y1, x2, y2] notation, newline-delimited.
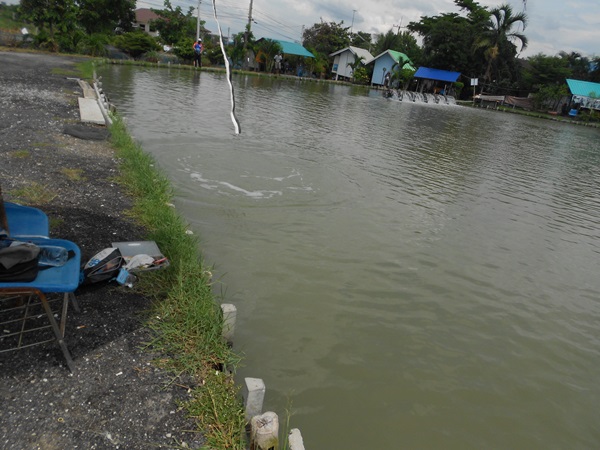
[0, 237, 81, 372]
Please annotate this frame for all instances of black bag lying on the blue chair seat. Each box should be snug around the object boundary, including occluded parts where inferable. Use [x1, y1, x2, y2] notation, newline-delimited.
[0, 241, 40, 282]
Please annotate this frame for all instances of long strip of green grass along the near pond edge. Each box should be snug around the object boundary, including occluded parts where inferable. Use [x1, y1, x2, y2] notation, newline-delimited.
[110, 117, 246, 450]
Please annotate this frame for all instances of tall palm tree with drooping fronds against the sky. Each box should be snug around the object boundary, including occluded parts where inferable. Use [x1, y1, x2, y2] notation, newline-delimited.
[477, 3, 527, 81]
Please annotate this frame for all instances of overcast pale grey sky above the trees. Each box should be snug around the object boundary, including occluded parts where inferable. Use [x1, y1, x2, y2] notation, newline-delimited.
[137, 0, 600, 57]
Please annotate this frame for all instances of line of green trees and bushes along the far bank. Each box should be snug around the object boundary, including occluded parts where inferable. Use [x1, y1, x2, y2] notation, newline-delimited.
[0, 0, 600, 102]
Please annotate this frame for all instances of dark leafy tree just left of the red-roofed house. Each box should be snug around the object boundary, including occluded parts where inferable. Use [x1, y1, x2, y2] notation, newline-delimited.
[77, 0, 135, 34]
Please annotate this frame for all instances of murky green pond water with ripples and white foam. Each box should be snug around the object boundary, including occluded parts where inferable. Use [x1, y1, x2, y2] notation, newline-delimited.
[101, 67, 600, 450]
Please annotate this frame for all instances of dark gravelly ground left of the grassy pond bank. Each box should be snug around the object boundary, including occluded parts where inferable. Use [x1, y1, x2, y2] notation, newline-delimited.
[0, 50, 203, 450]
